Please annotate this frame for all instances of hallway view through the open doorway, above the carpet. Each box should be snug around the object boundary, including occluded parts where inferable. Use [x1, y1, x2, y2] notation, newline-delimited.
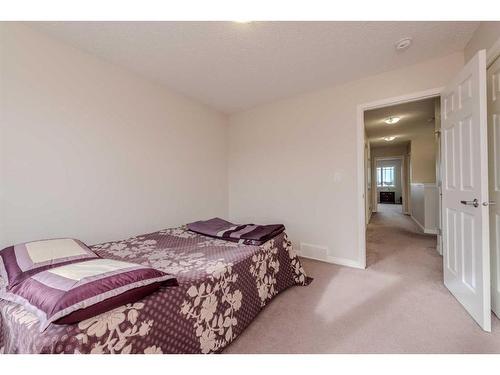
[364, 96, 440, 238]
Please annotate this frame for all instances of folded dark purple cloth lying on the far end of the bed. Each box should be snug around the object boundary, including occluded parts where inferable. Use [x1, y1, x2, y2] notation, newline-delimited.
[187, 217, 285, 245]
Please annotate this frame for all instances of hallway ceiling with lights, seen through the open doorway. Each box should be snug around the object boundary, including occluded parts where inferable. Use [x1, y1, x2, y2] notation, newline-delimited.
[365, 98, 439, 147]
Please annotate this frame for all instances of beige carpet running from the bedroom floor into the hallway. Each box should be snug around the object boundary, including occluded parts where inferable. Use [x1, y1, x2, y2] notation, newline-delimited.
[225, 205, 500, 353]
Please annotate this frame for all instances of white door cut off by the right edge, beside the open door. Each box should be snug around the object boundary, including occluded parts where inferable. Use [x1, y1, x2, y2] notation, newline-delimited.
[487, 53, 500, 317]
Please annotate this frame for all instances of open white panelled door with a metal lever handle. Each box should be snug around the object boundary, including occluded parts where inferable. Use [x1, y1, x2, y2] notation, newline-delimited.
[441, 50, 491, 331]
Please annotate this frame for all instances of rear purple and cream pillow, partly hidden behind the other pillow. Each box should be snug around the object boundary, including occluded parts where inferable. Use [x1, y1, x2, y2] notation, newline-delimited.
[0, 238, 99, 288]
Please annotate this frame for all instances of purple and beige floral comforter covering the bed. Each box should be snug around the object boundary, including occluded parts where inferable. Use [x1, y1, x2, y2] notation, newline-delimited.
[0, 227, 310, 353]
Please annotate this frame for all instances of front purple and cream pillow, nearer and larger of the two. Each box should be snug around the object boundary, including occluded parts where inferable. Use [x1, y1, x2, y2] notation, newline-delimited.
[0, 258, 177, 331]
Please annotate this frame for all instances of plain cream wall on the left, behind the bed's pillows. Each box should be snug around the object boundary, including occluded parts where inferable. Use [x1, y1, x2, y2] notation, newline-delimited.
[0, 23, 228, 249]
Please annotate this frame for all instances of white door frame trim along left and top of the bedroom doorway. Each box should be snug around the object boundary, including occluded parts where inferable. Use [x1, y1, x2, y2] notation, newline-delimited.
[356, 87, 444, 268]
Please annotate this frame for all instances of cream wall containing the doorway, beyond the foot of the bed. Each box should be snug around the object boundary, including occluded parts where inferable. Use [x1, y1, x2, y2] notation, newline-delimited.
[229, 53, 464, 266]
